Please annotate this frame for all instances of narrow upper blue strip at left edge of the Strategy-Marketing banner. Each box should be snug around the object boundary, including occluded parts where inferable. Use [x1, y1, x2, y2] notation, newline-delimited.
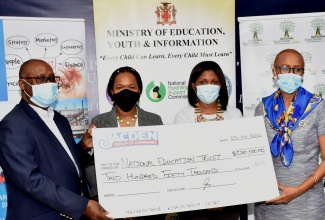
[0, 20, 8, 101]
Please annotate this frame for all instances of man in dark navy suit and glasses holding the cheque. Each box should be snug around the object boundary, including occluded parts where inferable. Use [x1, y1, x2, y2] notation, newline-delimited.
[0, 60, 112, 220]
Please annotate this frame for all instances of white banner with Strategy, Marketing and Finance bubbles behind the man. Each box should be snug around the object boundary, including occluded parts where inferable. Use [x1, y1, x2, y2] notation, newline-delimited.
[0, 17, 88, 138]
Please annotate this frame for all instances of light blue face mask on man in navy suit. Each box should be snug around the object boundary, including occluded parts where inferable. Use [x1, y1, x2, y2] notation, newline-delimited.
[24, 80, 59, 108]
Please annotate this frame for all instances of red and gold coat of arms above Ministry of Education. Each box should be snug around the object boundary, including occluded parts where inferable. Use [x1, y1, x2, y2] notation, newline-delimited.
[155, 2, 177, 25]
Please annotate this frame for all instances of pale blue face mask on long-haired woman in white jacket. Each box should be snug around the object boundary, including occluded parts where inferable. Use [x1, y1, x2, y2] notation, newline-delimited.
[196, 84, 220, 104]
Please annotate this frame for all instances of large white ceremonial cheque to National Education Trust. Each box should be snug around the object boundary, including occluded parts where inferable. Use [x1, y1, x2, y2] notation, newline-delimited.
[93, 116, 279, 218]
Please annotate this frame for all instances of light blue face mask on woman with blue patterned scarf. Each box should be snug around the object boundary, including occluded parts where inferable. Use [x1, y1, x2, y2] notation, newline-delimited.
[277, 73, 302, 94]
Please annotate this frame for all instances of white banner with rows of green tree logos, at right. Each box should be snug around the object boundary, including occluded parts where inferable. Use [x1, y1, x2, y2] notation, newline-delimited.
[238, 13, 325, 117]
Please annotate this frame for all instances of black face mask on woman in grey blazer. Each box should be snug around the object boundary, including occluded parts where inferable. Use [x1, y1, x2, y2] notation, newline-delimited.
[113, 89, 140, 112]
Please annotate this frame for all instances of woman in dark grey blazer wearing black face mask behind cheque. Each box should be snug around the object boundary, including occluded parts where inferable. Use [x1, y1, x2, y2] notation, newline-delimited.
[81, 66, 166, 220]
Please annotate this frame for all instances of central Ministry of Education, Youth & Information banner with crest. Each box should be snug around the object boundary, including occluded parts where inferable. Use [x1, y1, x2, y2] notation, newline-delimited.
[93, 0, 236, 124]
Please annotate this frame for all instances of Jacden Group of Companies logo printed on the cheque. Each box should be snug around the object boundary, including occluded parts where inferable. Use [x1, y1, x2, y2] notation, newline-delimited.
[98, 131, 159, 149]
